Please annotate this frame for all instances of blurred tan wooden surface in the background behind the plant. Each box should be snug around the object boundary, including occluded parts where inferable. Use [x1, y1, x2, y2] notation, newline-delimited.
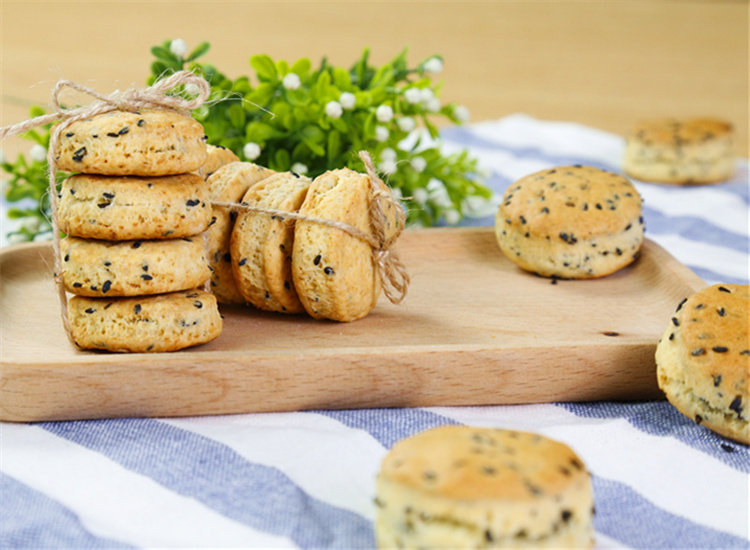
[0, 0, 748, 156]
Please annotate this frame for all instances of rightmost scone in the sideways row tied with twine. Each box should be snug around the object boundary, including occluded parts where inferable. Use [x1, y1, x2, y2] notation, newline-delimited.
[292, 168, 398, 322]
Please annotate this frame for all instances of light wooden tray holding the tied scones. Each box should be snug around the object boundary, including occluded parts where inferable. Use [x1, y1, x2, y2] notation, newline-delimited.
[0, 228, 705, 421]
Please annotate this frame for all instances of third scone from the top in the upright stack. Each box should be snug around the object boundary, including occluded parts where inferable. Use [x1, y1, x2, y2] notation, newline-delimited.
[60, 236, 210, 296]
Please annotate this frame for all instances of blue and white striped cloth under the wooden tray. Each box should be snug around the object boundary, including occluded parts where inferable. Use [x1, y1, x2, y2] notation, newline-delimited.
[0, 115, 750, 548]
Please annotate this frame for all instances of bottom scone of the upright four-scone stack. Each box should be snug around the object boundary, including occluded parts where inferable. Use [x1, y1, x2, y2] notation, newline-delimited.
[68, 289, 222, 353]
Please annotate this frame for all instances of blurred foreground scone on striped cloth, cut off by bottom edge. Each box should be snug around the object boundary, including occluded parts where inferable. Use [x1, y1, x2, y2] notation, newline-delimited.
[375, 426, 594, 548]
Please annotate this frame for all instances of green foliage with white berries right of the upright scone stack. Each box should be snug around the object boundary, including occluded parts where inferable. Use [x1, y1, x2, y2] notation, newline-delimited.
[149, 39, 491, 225]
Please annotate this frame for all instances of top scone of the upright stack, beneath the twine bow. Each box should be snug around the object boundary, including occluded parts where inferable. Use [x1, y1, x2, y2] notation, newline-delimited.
[56, 110, 206, 176]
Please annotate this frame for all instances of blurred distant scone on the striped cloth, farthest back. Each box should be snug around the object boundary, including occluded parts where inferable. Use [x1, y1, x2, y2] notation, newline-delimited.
[624, 118, 735, 184]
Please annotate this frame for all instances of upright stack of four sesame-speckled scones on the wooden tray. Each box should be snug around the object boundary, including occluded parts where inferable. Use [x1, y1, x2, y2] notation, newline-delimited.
[56, 111, 222, 352]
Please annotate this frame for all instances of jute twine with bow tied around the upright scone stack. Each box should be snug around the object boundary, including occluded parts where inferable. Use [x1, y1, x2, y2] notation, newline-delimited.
[0, 71, 211, 347]
